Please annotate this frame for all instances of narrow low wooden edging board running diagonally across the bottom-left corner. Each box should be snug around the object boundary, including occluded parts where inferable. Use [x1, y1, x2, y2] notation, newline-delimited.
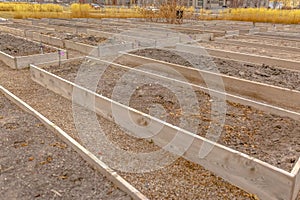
[0, 85, 148, 200]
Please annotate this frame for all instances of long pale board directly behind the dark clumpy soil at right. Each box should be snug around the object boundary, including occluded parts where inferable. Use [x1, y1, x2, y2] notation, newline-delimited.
[176, 44, 300, 71]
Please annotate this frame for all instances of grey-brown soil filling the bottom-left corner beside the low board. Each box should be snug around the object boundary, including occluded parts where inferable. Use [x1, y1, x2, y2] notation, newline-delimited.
[0, 93, 131, 200]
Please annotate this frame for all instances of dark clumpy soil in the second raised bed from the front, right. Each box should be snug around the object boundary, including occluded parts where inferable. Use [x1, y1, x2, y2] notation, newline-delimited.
[133, 49, 300, 90]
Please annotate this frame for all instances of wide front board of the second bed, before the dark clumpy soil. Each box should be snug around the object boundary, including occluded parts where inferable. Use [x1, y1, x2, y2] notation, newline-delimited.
[116, 53, 300, 115]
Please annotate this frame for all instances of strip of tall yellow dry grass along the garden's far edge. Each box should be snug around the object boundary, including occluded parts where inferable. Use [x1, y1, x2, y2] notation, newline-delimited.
[0, 2, 300, 24]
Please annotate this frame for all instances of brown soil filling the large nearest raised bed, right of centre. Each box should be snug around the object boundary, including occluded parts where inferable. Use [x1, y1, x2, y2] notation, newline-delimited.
[41, 57, 300, 171]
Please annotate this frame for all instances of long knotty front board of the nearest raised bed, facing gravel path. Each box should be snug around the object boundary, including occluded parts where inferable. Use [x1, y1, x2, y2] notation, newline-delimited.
[30, 65, 293, 199]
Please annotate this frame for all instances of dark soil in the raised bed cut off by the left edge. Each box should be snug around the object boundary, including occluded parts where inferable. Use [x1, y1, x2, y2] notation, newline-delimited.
[0, 33, 57, 56]
